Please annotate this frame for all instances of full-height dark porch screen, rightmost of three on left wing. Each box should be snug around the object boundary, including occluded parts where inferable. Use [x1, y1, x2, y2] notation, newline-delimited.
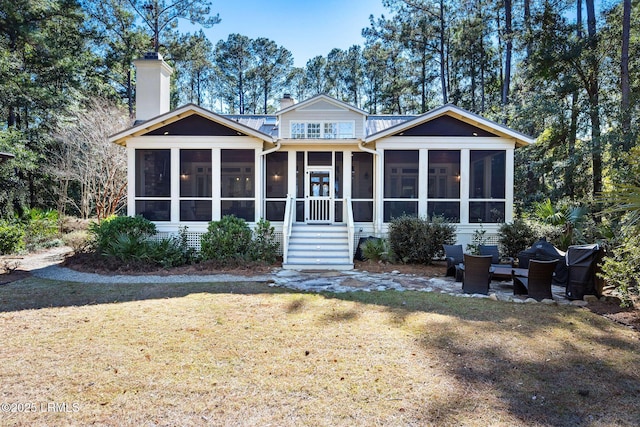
[220, 150, 255, 222]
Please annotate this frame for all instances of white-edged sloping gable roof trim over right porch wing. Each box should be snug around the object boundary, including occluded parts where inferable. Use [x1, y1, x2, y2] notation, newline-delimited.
[364, 104, 535, 147]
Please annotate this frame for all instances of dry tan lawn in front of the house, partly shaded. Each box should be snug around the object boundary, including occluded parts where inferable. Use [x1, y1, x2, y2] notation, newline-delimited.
[0, 279, 640, 426]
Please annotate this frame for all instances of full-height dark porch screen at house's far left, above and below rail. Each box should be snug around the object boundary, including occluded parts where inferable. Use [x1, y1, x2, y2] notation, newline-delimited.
[135, 150, 171, 221]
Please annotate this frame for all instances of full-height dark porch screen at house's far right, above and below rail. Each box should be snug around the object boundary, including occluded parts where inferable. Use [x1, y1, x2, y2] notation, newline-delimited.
[469, 150, 506, 223]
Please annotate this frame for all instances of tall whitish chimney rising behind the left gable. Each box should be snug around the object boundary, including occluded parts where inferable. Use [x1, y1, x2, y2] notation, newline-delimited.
[133, 52, 173, 122]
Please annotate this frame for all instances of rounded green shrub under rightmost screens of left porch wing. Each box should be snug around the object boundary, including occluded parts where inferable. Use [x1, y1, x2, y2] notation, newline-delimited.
[200, 215, 252, 263]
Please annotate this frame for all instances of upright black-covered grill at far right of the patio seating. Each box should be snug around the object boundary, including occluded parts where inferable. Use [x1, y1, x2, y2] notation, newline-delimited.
[566, 244, 602, 299]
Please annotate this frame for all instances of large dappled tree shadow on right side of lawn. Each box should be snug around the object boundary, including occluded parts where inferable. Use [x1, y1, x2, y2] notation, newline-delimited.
[325, 292, 640, 426]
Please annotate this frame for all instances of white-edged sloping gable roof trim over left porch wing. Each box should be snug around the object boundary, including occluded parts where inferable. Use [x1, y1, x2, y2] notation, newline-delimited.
[109, 104, 276, 145]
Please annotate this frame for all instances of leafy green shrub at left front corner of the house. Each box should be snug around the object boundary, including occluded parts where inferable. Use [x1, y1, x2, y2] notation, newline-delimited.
[89, 216, 156, 253]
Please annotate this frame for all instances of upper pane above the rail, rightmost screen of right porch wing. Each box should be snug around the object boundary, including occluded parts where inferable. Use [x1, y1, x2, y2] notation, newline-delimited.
[469, 150, 506, 199]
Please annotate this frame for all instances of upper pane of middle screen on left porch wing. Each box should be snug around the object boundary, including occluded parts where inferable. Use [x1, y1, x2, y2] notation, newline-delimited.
[180, 150, 211, 197]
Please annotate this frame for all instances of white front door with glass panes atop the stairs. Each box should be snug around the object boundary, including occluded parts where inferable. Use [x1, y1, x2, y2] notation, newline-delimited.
[305, 166, 335, 224]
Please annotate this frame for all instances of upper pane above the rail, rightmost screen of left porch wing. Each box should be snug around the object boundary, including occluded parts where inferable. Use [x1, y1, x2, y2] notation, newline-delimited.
[221, 150, 255, 197]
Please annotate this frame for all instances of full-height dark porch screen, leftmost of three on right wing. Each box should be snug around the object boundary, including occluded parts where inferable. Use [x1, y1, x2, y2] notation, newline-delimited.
[384, 150, 420, 222]
